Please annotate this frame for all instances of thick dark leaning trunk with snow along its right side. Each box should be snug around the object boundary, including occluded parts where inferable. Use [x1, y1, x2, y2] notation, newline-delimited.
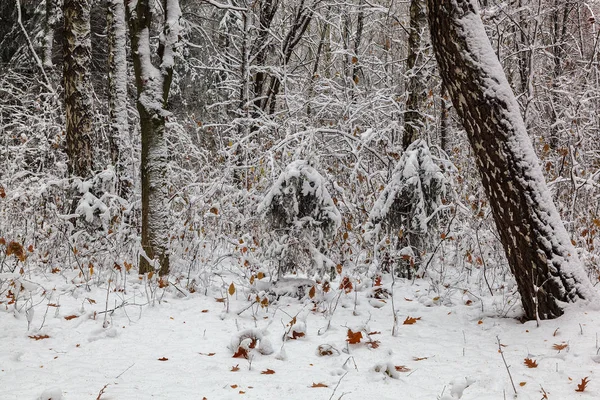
[427, 0, 596, 319]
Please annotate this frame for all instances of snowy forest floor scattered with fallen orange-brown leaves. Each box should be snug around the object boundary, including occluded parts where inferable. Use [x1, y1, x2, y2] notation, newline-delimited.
[0, 271, 600, 400]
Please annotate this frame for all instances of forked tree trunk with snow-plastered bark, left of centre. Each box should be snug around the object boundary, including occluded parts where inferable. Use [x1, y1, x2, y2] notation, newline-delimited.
[127, 0, 181, 275]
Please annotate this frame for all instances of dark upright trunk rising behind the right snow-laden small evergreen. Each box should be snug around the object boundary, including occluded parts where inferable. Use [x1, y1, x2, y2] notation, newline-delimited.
[402, 0, 427, 150]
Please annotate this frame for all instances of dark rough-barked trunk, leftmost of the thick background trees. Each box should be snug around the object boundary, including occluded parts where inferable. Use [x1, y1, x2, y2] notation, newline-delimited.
[63, 0, 94, 178]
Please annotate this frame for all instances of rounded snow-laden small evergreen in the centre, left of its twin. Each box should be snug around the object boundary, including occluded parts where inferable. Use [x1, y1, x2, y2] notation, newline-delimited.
[258, 160, 342, 277]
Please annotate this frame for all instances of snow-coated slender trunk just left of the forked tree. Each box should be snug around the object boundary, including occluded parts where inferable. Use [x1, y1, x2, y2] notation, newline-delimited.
[106, 0, 132, 197]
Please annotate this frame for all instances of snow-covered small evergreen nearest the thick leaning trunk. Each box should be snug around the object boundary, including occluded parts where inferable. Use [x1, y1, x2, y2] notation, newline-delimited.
[366, 140, 449, 278]
